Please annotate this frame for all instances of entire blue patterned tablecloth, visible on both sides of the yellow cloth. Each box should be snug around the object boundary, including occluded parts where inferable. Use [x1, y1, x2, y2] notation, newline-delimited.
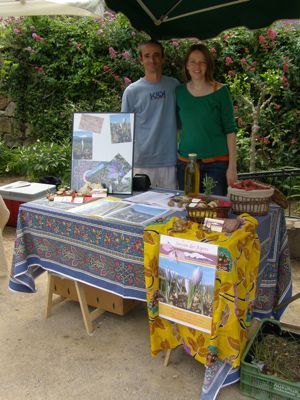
[9, 200, 292, 318]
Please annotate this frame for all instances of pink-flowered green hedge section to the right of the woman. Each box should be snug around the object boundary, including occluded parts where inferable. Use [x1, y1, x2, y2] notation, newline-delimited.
[209, 24, 300, 172]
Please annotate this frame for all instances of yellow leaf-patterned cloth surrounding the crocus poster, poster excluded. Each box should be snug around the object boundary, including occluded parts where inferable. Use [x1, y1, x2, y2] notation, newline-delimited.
[144, 214, 260, 368]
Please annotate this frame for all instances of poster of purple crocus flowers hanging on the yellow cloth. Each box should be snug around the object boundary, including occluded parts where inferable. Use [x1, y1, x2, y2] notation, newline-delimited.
[159, 235, 218, 333]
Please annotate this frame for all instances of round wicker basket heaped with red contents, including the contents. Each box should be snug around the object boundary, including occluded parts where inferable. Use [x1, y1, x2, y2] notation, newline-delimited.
[228, 179, 274, 216]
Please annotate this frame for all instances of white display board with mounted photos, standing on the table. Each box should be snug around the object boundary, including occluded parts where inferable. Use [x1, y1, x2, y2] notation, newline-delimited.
[71, 112, 134, 194]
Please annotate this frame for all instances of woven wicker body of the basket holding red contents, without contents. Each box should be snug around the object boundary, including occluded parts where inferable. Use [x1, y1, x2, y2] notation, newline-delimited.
[228, 187, 274, 216]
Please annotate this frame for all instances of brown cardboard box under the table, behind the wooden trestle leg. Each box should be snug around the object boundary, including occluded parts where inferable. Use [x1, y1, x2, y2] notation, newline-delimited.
[53, 275, 139, 315]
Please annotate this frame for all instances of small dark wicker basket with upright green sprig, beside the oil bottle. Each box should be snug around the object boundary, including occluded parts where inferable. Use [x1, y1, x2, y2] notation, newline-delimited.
[186, 176, 231, 224]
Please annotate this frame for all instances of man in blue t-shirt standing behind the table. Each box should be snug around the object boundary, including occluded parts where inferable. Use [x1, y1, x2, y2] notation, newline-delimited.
[121, 40, 179, 189]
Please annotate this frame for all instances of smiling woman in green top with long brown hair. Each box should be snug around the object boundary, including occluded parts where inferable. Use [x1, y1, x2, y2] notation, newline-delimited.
[176, 44, 237, 196]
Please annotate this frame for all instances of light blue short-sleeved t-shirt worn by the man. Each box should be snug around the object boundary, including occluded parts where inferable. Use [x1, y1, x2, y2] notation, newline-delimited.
[121, 76, 179, 168]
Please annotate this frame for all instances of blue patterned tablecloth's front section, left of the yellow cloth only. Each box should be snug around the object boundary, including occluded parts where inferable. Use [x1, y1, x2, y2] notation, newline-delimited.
[9, 200, 146, 301]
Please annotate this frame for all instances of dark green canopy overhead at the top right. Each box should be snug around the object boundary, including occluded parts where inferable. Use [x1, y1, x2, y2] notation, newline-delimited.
[106, 0, 300, 39]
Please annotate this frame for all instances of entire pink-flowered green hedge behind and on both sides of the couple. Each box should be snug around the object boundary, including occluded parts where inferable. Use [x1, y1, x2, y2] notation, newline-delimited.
[0, 12, 300, 178]
